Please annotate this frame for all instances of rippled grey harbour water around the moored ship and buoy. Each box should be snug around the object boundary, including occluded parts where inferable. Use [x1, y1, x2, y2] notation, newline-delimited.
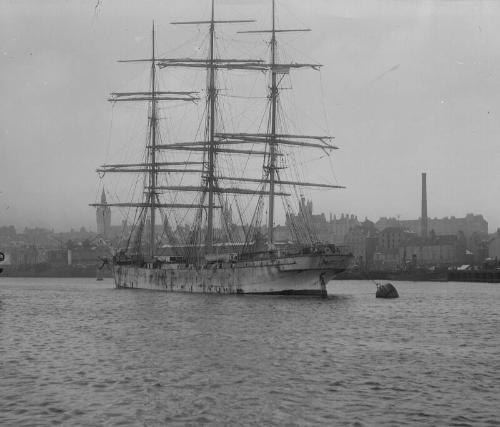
[0, 277, 500, 426]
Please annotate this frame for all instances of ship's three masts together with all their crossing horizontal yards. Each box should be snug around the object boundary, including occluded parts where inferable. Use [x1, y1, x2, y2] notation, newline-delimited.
[98, 0, 339, 257]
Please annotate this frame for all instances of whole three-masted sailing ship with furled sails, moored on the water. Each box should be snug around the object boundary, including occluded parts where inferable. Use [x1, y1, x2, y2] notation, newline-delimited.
[91, 0, 352, 296]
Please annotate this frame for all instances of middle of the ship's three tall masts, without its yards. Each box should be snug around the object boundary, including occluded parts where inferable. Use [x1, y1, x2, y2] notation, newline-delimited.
[206, 0, 217, 252]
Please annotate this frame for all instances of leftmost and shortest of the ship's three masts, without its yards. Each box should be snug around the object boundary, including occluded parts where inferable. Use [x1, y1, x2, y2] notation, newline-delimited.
[148, 21, 157, 258]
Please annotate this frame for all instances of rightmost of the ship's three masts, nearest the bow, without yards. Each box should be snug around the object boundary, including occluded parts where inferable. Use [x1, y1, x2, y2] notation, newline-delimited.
[267, 0, 278, 245]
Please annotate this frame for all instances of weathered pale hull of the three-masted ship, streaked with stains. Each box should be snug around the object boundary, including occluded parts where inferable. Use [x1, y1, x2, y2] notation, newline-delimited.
[113, 255, 351, 295]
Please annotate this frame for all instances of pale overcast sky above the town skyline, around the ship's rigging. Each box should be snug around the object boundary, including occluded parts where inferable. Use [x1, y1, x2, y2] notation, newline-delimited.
[0, 0, 500, 231]
